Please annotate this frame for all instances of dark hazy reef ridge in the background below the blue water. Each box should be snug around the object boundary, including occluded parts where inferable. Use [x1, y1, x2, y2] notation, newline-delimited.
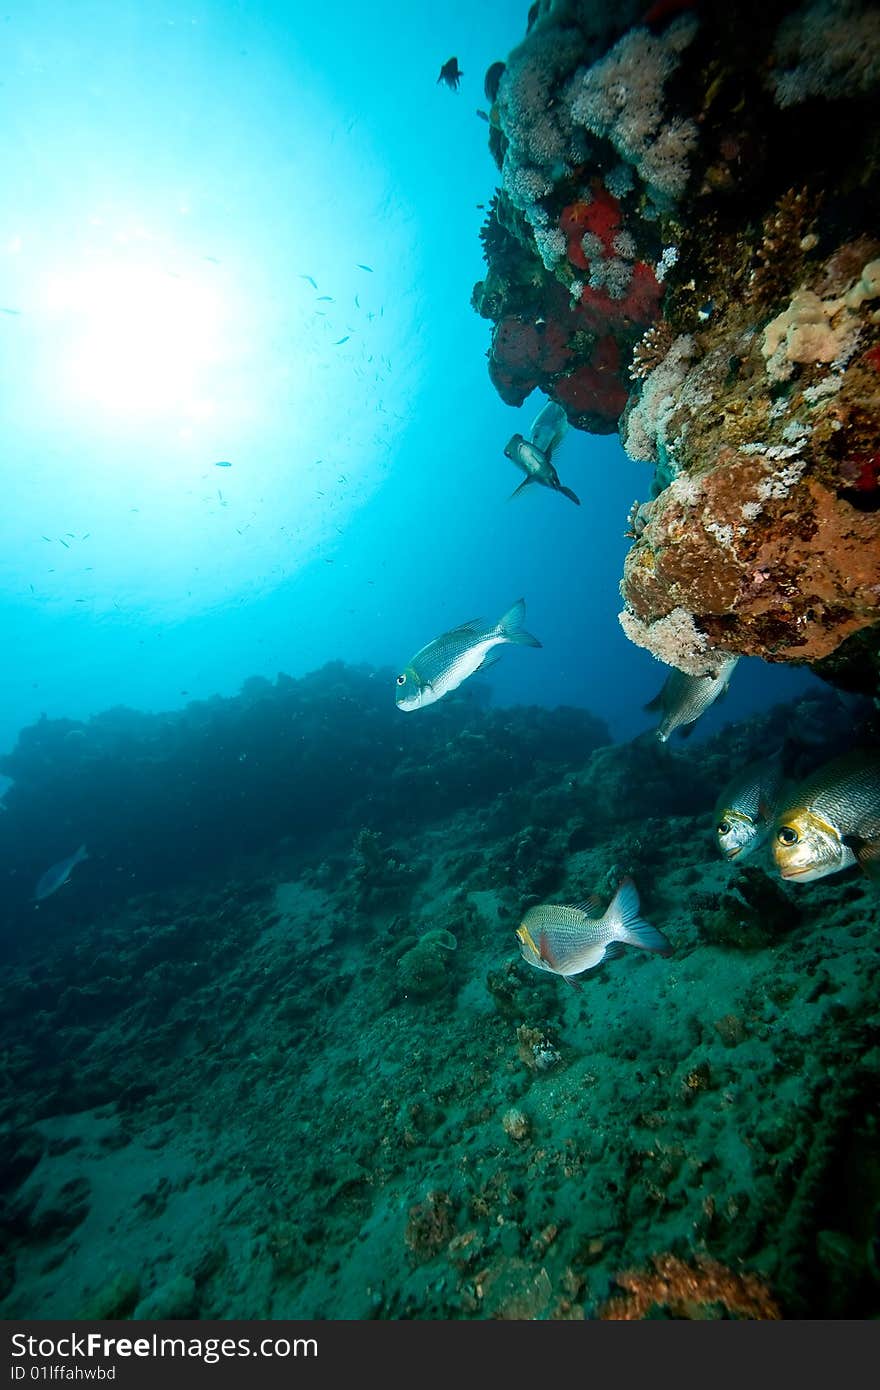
[0, 662, 610, 941]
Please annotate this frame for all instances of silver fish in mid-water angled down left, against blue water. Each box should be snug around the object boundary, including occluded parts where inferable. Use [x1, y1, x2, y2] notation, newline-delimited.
[395, 599, 541, 710]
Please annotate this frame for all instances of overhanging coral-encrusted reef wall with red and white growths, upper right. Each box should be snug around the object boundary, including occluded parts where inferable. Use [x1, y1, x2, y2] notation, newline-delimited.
[474, 0, 880, 691]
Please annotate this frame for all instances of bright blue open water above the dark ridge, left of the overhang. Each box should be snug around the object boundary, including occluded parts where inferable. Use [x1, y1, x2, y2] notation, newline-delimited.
[0, 0, 808, 748]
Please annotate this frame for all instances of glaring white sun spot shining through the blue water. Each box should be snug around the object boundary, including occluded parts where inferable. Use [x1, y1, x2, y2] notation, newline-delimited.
[47, 264, 222, 418]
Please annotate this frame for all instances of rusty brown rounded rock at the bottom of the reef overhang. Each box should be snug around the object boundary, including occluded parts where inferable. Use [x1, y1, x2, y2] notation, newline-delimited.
[624, 449, 880, 662]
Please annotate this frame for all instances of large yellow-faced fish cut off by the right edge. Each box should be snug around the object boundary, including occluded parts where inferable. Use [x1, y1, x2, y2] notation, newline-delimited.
[773, 749, 880, 883]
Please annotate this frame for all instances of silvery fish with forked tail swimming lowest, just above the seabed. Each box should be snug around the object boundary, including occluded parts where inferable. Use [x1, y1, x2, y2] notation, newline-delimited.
[516, 878, 673, 980]
